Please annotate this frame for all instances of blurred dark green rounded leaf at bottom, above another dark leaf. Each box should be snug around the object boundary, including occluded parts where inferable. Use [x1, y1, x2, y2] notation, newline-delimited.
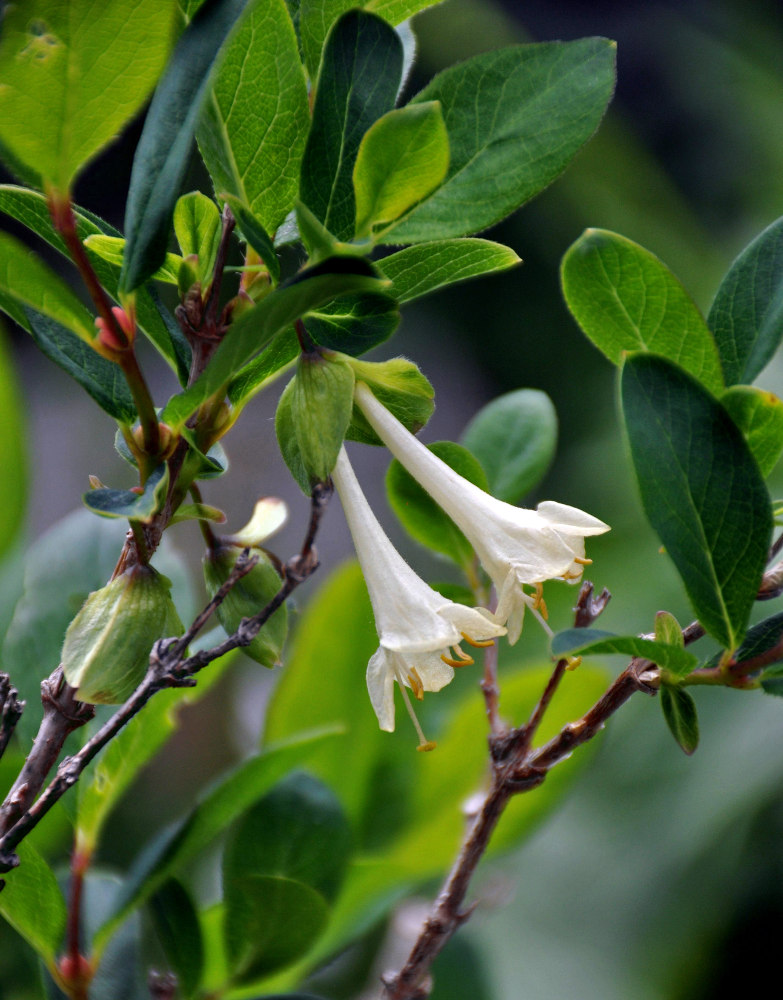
[223, 771, 351, 904]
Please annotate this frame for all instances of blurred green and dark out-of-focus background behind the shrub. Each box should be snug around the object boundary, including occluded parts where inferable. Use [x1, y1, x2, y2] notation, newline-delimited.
[0, 0, 783, 1000]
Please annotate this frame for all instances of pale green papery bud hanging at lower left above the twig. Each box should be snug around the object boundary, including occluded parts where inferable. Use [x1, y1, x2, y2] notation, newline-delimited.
[62, 566, 183, 705]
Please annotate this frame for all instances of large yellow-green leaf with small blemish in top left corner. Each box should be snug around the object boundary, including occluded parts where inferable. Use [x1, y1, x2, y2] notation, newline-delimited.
[0, 0, 176, 192]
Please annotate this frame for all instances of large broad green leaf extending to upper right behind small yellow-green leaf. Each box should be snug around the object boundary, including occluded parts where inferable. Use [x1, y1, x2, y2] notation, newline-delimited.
[383, 38, 615, 243]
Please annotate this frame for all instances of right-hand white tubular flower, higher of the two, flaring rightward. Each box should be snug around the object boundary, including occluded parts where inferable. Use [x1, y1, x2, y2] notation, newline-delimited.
[356, 382, 609, 644]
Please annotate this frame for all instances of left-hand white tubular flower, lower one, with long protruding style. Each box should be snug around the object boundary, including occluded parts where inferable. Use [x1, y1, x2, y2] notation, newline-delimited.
[332, 448, 506, 750]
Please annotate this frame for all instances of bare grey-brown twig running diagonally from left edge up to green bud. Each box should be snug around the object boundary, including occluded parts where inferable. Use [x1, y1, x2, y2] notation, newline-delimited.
[0, 484, 332, 872]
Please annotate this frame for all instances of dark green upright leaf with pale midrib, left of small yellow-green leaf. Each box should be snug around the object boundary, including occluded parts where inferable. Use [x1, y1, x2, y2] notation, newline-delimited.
[299, 10, 402, 240]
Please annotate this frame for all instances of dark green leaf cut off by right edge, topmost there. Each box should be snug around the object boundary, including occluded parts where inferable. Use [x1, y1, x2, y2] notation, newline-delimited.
[707, 213, 783, 385]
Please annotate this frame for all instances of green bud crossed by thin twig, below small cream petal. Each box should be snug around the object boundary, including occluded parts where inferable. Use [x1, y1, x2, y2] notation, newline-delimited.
[204, 545, 288, 667]
